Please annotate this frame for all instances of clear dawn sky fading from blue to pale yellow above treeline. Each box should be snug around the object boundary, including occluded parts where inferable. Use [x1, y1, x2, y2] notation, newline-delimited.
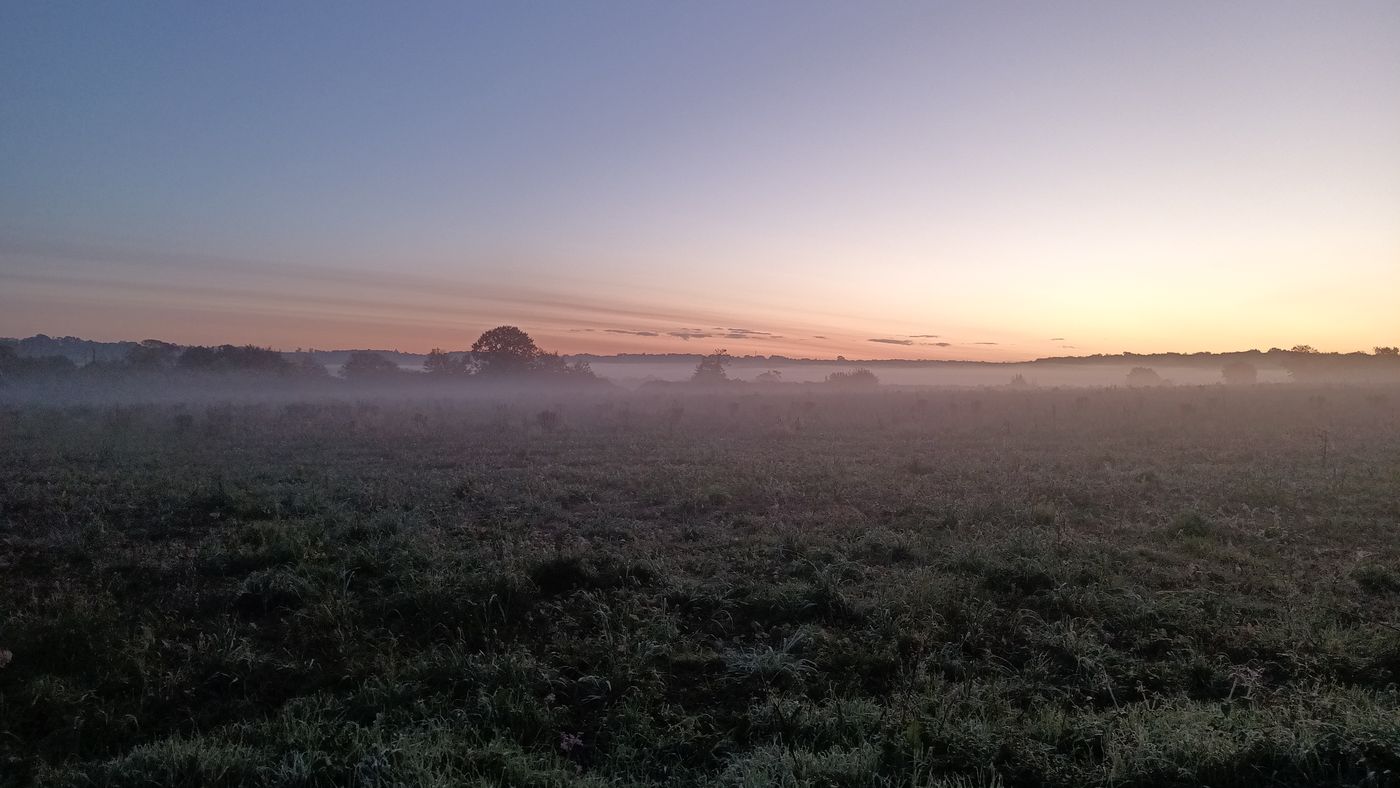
[0, 0, 1400, 360]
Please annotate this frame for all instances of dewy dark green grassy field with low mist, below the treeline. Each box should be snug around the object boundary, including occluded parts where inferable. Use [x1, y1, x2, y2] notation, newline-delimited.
[0, 385, 1400, 788]
